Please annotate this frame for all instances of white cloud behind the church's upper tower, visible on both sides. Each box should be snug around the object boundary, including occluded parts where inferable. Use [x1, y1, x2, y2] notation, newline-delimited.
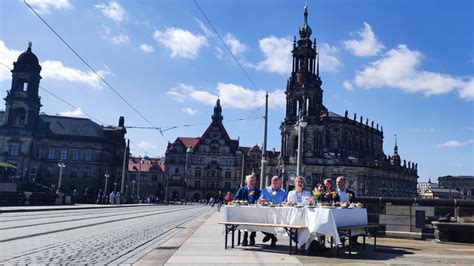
[256, 36, 341, 75]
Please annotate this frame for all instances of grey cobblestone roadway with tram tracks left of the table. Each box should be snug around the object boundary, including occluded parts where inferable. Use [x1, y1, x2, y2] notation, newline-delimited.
[0, 205, 210, 264]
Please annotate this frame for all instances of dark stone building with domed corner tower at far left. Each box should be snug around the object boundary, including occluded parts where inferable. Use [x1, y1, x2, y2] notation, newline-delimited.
[0, 43, 126, 193]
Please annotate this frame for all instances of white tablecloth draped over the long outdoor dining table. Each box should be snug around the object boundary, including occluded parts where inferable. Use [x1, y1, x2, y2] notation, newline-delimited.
[223, 206, 367, 247]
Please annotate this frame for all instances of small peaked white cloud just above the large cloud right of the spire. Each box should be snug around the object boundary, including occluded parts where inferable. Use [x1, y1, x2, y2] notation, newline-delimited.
[344, 22, 384, 56]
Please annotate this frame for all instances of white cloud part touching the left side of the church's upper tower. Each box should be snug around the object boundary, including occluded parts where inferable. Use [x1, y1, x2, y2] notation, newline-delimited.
[256, 36, 293, 75]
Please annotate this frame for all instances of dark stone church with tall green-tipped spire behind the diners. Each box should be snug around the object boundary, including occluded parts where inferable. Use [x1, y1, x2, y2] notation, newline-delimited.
[278, 7, 418, 197]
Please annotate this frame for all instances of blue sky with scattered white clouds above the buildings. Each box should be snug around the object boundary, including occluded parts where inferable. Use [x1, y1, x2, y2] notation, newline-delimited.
[0, 0, 474, 181]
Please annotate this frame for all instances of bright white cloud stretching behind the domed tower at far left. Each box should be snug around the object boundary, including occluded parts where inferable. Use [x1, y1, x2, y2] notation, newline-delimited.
[0, 40, 111, 88]
